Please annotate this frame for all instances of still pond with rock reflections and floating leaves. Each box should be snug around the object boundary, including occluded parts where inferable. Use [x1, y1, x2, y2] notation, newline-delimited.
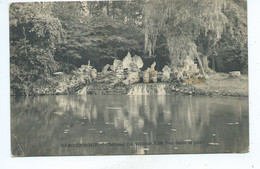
[11, 95, 249, 156]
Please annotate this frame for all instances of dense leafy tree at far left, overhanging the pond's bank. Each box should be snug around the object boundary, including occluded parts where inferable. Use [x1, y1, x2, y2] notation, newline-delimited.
[10, 3, 63, 95]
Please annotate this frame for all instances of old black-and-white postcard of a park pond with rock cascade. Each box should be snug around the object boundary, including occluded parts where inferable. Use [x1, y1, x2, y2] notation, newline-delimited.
[9, 0, 249, 157]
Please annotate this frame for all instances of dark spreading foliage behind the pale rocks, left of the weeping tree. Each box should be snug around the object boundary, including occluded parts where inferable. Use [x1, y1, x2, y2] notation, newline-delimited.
[52, 2, 143, 71]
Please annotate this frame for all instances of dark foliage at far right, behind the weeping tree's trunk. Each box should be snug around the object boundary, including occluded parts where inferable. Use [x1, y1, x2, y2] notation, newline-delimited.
[211, 0, 248, 73]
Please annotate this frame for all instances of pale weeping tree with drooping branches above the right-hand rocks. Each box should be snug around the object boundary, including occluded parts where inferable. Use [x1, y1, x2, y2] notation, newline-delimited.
[144, 0, 248, 74]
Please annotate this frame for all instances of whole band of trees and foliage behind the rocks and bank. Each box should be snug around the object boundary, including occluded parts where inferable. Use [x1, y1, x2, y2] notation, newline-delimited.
[10, 0, 247, 93]
